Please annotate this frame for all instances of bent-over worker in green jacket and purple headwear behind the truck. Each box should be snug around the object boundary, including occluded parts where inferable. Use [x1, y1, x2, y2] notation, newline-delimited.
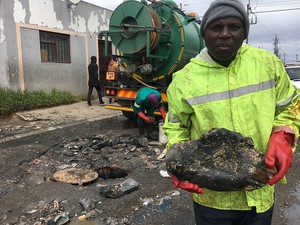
[133, 87, 166, 140]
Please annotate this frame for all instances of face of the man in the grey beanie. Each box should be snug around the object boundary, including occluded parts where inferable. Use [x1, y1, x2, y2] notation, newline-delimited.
[204, 17, 245, 66]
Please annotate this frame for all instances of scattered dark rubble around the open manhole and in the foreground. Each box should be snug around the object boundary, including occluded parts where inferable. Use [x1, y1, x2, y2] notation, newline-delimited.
[2, 134, 177, 225]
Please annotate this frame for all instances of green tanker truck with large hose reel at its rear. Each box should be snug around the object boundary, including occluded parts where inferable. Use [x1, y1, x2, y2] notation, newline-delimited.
[99, 0, 204, 119]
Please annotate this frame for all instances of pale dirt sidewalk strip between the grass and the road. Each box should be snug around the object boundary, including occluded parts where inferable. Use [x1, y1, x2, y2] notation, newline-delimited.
[0, 100, 123, 143]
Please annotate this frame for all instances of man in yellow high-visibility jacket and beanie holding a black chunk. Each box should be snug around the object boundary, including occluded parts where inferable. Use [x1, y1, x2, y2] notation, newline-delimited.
[163, 0, 300, 225]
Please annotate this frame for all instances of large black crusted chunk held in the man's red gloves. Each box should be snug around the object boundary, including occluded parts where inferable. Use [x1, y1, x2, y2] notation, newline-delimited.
[166, 129, 276, 191]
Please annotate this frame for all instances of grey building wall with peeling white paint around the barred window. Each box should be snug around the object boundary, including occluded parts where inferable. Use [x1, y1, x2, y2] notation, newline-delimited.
[0, 0, 112, 96]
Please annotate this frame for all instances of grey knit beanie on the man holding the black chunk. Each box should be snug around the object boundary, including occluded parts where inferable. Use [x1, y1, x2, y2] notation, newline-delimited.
[201, 0, 249, 39]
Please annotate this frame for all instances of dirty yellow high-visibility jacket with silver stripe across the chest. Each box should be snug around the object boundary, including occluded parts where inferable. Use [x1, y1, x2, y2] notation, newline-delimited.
[163, 45, 300, 213]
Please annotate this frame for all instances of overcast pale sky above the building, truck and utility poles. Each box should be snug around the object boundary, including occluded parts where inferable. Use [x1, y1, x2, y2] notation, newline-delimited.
[84, 0, 300, 63]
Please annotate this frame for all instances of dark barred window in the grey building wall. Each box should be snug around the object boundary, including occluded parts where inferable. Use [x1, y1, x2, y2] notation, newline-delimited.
[40, 31, 71, 63]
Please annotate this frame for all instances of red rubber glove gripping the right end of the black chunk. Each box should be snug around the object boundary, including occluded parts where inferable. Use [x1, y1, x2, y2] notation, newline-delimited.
[265, 131, 295, 185]
